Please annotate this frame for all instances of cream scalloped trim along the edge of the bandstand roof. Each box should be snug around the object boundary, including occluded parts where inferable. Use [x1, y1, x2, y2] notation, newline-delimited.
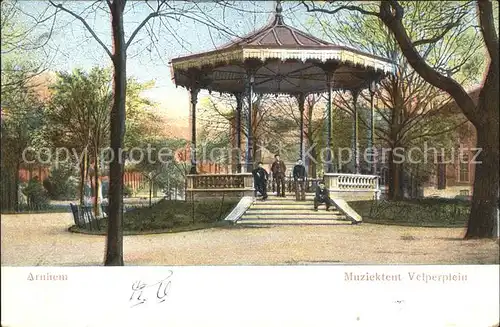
[172, 48, 396, 74]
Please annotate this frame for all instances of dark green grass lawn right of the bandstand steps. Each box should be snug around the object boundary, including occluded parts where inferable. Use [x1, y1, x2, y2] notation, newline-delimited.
[349, 199, 470, 227]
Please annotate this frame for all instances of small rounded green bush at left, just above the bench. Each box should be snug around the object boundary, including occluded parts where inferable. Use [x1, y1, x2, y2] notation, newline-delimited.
[43, 165, 78, 200]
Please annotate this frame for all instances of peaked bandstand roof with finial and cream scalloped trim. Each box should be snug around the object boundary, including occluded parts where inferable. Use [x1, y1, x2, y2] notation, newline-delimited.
[171, 1, 395, 94]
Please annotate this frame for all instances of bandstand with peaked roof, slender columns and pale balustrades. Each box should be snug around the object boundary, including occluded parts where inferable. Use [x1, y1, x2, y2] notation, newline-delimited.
[170, 1, 395, 200]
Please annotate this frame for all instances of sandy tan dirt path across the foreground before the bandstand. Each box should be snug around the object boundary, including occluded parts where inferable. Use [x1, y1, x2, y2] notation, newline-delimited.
[1, 213, 499, 266]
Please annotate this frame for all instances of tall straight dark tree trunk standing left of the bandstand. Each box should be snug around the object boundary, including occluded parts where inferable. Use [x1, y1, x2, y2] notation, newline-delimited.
[104, 0, 127, 266]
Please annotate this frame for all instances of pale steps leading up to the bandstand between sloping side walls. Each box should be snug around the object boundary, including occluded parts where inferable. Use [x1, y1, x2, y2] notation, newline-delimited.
[236, 194, 352, 226]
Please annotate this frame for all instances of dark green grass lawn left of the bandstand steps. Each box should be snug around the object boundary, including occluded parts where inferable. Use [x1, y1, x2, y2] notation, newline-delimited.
[70, 200, 238, 235]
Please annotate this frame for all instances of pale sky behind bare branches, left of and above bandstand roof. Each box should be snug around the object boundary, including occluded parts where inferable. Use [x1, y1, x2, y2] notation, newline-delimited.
[21, 0, 332, 117]
